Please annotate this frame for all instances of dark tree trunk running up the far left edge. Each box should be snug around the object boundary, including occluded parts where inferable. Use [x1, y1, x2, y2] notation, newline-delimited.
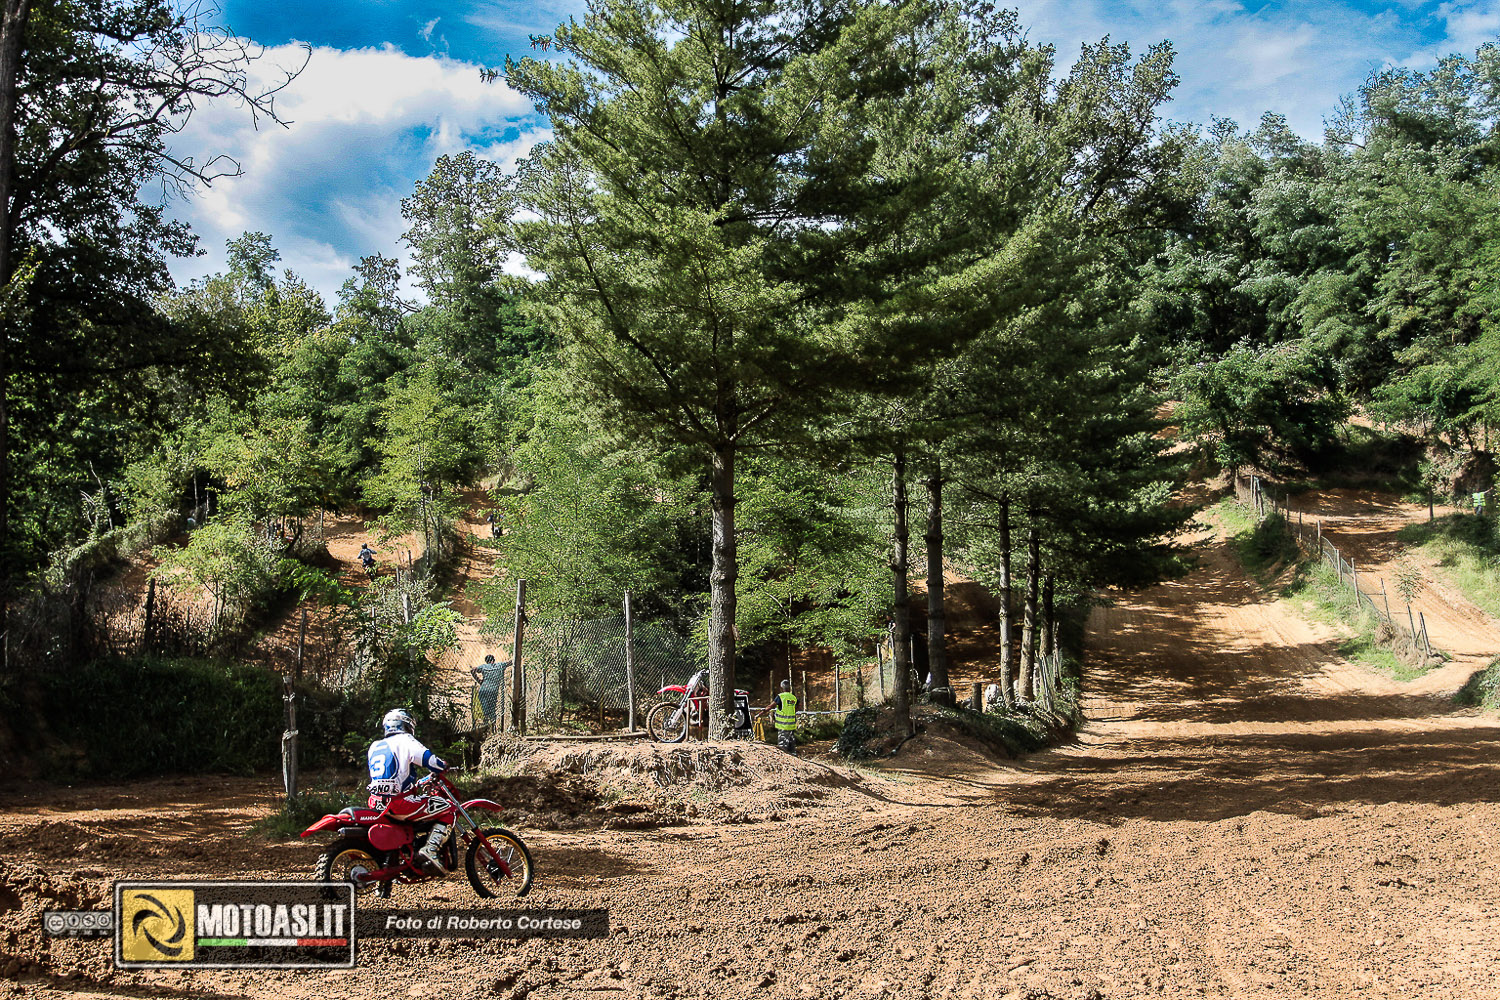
[0, 0, 32, 641]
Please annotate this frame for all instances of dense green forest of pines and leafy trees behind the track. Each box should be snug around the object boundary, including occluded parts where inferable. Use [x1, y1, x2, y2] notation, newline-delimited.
[0, 0, 1500, 746]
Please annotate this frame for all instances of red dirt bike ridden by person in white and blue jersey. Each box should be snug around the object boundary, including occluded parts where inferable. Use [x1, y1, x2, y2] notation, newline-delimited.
[302, 774, 536, 900]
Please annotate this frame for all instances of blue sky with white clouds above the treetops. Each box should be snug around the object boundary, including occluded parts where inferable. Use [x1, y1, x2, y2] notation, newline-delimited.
[171, 0, 1500, 304]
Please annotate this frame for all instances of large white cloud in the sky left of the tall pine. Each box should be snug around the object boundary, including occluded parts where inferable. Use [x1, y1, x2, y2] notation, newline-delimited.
[161, 46, 539, 304]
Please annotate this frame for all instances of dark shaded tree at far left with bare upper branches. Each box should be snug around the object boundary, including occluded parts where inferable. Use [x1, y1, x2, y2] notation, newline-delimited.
[0, 0, 301, 610]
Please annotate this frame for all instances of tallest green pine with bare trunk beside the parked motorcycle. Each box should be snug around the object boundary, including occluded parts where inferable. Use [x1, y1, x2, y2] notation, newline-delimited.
[506, 0, 1044, 732]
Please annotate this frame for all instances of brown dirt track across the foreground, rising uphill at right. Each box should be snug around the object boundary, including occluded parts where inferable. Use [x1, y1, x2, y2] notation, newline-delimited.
[0, 494, 1500, 1000]
